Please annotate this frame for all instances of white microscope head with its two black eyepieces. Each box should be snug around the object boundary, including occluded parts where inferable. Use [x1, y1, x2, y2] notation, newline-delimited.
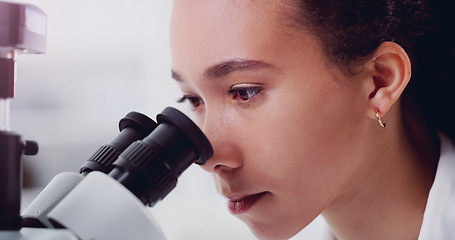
[0, 104, 213, 240]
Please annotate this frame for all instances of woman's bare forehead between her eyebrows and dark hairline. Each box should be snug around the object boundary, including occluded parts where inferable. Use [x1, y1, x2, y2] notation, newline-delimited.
[171, 0, 310, 73]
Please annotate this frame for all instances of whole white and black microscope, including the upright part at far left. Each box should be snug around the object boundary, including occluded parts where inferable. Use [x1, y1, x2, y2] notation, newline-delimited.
[0, 2, 213, 240]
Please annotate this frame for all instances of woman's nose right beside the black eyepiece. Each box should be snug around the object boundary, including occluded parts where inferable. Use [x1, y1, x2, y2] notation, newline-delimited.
[201, 111, 243, 173]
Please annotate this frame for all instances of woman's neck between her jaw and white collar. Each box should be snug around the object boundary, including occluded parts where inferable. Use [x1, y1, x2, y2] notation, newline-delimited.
[323, 105, 439, 240]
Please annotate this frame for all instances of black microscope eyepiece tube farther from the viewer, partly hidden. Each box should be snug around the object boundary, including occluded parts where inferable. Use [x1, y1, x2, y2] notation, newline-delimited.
[80, 112, 158, 175]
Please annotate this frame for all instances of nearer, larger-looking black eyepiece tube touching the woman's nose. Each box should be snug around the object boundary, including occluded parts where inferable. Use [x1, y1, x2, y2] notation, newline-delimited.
[109, 107, 213, 206]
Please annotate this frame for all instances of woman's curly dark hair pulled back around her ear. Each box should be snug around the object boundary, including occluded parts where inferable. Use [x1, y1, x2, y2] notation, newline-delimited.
[291, 0, 455, 139]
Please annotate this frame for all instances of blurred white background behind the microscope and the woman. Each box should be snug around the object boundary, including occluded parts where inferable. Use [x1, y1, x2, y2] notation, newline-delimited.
[6, 0, 255, 240]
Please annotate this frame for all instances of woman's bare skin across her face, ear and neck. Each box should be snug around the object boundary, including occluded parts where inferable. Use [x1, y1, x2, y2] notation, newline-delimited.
[171, 0, 437, 239]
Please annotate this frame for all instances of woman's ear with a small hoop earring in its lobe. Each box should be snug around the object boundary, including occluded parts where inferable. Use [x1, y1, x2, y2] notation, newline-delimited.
[366, 42, 411, 119]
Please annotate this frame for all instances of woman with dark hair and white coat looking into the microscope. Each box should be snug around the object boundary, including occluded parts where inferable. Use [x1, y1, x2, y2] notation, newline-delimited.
[171, 0, 455, 239]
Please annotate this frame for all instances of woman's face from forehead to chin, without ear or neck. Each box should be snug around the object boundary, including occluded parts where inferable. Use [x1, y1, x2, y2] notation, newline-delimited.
[171, 0, 368, 238]
